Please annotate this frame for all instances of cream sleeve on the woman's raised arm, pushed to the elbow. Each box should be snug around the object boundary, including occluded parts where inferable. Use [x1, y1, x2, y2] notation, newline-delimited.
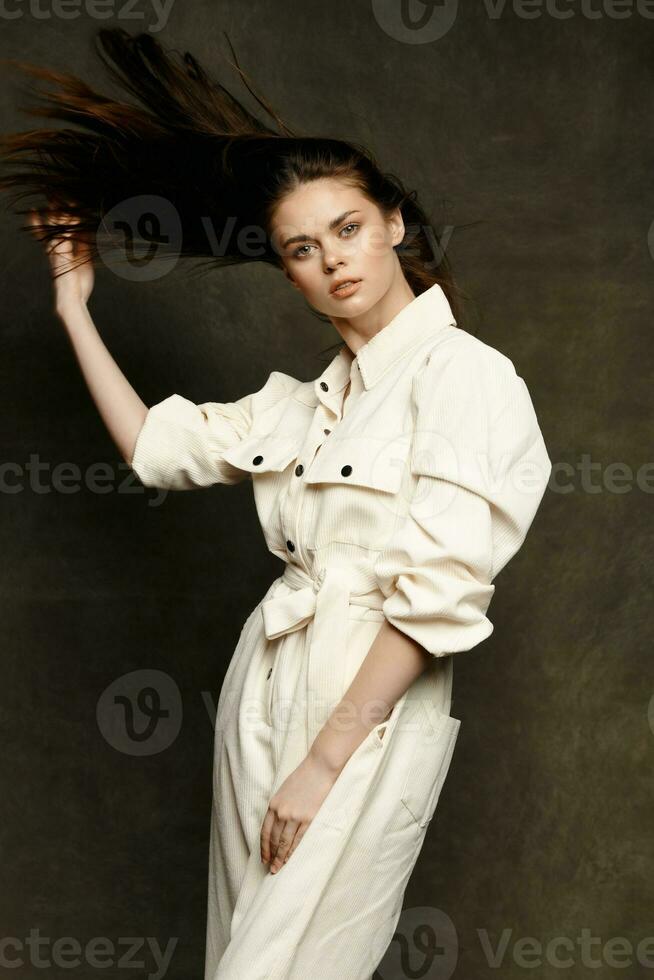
[131, 371, 300, 490]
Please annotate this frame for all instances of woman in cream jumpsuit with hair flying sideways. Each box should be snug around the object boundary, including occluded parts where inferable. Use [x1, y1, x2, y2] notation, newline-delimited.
[2, 30, 551, 980]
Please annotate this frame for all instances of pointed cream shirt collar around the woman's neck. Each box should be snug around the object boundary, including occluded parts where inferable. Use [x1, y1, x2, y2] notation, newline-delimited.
[313, 283, 457, 402]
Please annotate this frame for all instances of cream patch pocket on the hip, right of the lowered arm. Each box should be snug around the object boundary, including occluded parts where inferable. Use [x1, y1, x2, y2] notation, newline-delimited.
[401, 714, 461, 830]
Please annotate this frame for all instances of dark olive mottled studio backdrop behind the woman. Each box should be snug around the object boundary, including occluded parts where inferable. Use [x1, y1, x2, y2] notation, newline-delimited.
[0, 0, 654, 980]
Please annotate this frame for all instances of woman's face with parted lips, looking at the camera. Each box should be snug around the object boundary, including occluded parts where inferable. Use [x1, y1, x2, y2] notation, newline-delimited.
[271, 177, 404, 319]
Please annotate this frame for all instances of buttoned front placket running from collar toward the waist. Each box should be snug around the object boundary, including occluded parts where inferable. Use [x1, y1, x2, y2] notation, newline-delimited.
[280, 358, 363, 571]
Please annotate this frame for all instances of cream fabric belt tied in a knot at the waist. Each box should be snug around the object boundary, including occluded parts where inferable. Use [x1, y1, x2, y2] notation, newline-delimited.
[261, 563, 384, 748]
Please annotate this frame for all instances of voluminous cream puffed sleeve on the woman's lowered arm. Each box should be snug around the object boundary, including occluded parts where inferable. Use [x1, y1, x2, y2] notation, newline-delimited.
[375, 339, 552, 657]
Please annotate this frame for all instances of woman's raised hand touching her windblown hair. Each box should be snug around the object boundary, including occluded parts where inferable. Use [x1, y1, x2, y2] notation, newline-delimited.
[29, 210, 95, 314]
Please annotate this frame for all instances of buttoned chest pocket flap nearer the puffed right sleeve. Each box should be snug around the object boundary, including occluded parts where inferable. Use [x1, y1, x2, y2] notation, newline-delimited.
[304, 435, 410, 493]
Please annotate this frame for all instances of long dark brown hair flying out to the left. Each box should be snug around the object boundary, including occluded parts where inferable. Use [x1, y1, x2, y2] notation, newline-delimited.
[0, 28, 472, 334]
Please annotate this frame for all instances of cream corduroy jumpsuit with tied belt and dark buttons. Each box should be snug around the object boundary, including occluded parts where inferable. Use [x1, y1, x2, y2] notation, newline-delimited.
[132, 285, 551, 980]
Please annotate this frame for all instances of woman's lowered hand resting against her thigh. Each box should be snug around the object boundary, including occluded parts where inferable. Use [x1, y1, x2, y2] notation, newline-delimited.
[261, 755, 338, 874]
